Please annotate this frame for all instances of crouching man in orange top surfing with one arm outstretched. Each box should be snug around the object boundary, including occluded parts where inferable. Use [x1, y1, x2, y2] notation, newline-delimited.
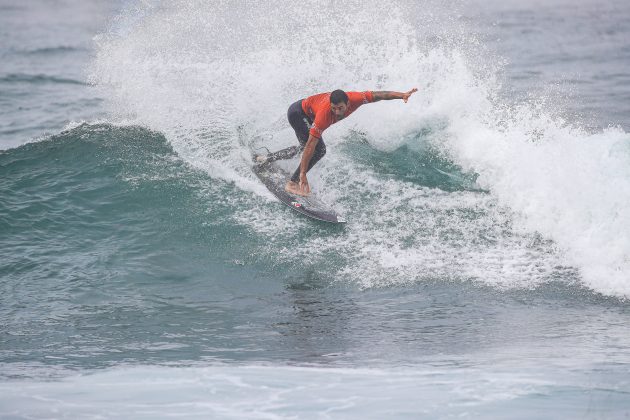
[256, 88, 418, 196]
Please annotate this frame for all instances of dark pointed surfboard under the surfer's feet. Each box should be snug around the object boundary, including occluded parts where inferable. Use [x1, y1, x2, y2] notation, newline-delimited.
[253, 162, 346, 223]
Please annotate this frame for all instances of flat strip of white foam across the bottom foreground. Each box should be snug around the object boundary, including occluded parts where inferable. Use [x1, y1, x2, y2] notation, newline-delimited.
[0, 357, 628, 419]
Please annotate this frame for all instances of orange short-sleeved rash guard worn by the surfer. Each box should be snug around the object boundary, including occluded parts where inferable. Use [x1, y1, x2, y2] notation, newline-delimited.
[302, 91, 374, 139]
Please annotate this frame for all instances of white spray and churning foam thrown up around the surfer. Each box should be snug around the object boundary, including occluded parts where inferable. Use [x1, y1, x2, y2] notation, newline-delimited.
[90, 1, 630, 296]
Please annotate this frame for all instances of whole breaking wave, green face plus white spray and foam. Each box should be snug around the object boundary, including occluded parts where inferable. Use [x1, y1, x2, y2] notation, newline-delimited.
[1, 1, 630, 297]
